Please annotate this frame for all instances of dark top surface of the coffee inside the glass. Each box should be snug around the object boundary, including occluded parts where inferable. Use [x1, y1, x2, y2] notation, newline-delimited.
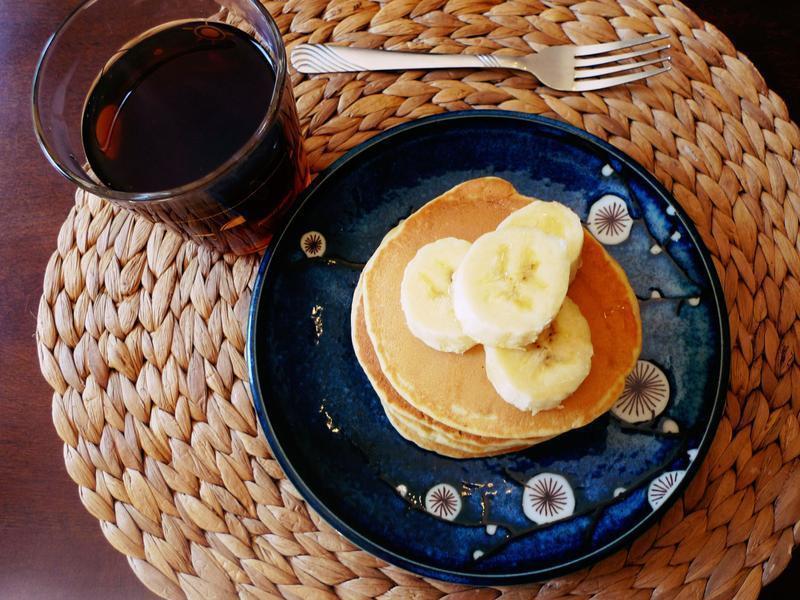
[83, 21, 275, 192]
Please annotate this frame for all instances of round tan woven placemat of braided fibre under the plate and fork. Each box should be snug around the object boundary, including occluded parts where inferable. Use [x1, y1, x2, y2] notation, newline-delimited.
[37, 0, 800, 599]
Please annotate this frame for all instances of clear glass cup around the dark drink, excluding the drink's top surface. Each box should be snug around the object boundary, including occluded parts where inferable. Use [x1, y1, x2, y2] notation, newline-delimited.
[33, 0, 309, 254]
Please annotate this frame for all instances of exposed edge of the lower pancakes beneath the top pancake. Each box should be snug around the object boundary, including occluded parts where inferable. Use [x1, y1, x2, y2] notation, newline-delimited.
[350, 274, 544, 458]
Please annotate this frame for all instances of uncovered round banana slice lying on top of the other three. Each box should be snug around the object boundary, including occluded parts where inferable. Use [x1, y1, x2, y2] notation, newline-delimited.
[453, 227, 569, 348]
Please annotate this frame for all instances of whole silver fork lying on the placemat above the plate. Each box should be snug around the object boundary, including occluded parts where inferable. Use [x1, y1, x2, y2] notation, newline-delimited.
[292, 34, 670, 92]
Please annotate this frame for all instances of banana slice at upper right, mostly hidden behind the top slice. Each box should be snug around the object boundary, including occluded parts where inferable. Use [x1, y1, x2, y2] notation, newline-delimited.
[497, 200, 583, 281]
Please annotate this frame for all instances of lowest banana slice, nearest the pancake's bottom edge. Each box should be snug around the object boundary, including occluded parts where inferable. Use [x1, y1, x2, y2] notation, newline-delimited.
[485, 298, 593, 414]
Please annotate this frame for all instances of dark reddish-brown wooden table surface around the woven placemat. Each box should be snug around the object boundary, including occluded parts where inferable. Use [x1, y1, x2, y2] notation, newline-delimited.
[0, 0, 800, 599]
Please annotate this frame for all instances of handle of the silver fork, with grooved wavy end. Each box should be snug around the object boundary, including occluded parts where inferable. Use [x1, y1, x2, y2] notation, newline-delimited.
[292, 44, 502, 73]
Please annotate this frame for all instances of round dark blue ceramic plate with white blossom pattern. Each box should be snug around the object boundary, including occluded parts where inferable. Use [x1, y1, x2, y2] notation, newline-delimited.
[248, 111, 729, 584]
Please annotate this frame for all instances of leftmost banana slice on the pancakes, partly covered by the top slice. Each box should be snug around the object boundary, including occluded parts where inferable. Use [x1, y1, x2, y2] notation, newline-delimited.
[400, 238, 475, 354]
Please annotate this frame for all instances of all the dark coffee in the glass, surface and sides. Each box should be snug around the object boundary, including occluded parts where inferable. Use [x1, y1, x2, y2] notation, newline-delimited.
[83, 21, 308, 254]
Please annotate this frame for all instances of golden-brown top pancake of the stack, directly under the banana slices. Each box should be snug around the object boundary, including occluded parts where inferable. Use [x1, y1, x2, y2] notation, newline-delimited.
[362, 177, 641, 439]
